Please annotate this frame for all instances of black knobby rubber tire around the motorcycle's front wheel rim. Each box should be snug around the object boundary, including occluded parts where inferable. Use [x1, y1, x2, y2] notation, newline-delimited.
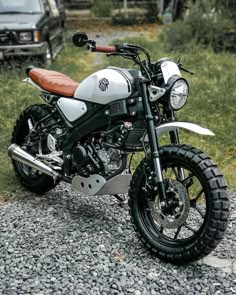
[129, 145, 229, 264]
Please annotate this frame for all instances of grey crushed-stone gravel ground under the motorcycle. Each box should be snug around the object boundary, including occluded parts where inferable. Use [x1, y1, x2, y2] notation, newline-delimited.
[0, 184, 236, 295]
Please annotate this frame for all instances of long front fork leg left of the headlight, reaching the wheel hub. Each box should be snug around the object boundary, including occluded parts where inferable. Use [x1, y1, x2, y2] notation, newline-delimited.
[141, 81, 167, 204]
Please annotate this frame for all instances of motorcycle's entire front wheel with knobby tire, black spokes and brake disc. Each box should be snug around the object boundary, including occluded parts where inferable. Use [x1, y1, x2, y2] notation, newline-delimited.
[129, 145, 229, 264]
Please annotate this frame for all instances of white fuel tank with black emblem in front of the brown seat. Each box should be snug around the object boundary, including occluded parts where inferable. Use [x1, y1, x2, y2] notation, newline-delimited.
[74, 69, 131, 104]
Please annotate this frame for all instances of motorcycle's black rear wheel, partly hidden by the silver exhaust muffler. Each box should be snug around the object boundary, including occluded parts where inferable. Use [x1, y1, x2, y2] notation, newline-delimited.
[11, 105, 58, 194]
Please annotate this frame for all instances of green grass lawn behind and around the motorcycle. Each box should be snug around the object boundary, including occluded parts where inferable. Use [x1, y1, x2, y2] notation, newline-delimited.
[0, 31, 236, 196]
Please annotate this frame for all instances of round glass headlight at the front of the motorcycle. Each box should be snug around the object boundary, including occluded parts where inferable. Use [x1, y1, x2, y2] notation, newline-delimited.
[170, 79, 188, 110]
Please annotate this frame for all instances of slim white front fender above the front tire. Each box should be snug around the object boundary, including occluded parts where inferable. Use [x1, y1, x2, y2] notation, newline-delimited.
[156, 122, 215, 137]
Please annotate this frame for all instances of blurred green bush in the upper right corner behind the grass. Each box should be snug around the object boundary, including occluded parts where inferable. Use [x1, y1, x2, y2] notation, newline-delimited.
[162, 2, 236, 52]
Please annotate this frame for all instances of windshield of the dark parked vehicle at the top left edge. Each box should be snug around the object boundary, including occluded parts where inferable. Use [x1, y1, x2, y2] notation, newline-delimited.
[0, 0, 42, 13]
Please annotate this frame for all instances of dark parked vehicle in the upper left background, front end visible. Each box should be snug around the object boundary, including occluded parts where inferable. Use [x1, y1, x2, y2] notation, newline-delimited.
[0, 0, 65, 63]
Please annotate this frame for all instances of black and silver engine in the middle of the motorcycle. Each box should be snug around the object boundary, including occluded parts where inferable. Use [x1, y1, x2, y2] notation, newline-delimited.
[71, 121, 146, 179]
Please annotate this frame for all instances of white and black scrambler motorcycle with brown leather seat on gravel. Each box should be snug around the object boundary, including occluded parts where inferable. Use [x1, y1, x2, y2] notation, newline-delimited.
[8, 32, 229, 264]
